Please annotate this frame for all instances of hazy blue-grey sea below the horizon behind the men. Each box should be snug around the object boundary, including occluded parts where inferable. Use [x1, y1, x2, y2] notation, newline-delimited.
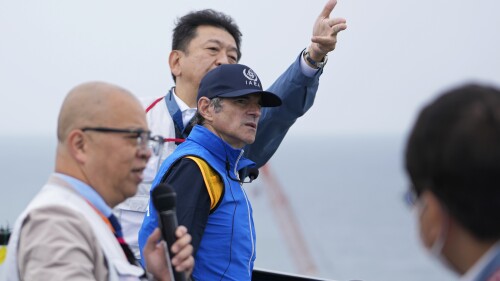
[0, 136, 458, 281]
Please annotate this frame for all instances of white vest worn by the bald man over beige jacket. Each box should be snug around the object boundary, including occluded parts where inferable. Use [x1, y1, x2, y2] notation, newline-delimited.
[0, 176, 144, 281]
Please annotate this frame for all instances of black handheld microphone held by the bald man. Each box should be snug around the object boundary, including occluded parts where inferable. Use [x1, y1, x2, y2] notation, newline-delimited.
[151, 183, 186, 281]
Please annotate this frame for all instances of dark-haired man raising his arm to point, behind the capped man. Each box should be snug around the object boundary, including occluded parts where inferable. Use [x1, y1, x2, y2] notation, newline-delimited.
[115, 0, 347, 258]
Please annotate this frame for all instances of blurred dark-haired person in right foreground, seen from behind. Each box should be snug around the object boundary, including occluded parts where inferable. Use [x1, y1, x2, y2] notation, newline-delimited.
[406, 84, 500, 281]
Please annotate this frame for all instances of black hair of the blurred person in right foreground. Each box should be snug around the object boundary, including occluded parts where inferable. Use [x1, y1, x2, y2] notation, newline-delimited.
[406, 84, 500, 240]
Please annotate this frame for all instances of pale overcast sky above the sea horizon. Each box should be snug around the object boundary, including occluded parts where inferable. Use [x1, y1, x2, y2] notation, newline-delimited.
[0, 0, 500, 136]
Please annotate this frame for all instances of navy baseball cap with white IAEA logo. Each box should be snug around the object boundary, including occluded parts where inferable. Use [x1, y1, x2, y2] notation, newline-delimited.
[197, 64, 281, 107]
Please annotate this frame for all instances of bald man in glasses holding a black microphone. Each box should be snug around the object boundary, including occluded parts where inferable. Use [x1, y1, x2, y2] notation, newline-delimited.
[2, 82, 193, 281]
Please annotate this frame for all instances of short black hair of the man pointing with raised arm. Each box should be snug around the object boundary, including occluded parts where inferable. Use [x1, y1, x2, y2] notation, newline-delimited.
[172, 9, 242, 81]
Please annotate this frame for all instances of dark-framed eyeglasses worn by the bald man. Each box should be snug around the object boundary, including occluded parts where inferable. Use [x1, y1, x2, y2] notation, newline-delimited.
[81, 127, 164, 155]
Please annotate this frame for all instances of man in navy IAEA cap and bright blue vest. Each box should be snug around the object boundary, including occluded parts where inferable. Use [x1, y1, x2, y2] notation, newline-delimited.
[139, 64, 281, 281]
